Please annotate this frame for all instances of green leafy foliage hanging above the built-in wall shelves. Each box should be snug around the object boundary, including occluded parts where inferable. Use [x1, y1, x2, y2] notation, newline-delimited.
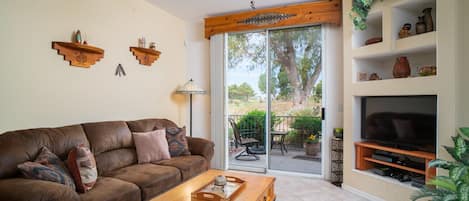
[349, 0, 375, 31]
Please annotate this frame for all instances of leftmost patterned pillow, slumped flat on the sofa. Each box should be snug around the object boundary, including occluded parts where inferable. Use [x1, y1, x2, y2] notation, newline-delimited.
[17, 147, 75, 190]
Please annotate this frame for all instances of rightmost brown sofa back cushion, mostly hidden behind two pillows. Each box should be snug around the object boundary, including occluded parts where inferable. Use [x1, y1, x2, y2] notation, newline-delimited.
[127, 119, 178, 133]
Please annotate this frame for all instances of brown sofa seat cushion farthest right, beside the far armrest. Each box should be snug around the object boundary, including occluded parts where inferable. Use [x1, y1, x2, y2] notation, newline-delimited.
[155, 155, 207, 181]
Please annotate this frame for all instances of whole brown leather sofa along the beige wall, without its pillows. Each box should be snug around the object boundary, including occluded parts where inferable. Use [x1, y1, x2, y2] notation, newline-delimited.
[0, 119, 214, 201]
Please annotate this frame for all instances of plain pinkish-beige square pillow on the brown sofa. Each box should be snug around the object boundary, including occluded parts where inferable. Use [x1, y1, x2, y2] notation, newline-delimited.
[132, 129, 171, 163]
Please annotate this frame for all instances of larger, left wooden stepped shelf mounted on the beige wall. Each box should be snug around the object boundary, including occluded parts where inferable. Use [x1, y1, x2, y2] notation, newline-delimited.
[52, 41, 104, 68]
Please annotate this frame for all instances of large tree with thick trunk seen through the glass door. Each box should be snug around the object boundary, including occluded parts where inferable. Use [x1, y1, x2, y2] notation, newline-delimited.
[228, 26, 322, 108]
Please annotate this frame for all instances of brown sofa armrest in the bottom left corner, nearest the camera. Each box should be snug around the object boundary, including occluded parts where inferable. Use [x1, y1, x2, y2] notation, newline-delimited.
[0, 178, 80, 201]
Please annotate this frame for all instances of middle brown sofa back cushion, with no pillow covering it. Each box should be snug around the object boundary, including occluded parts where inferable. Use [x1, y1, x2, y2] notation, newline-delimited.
[82, 121, 137, 175]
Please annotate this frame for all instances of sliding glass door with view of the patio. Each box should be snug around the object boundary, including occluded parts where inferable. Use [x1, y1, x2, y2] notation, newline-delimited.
[225, 26, 322, 174]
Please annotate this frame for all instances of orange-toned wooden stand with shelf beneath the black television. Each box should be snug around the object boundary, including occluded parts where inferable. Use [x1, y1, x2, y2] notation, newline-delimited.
[355, 142, 436, 182]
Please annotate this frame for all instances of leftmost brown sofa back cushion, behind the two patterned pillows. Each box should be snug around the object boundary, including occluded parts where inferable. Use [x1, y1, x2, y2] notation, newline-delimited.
[0, 125, 89, 178]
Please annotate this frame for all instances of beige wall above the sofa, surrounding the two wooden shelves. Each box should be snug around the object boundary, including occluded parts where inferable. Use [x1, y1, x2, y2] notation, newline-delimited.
[0, 0, 187, 133]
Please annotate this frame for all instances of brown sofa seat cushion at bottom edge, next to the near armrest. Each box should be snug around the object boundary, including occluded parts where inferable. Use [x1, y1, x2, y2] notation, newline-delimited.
[80, 177, 141, 201]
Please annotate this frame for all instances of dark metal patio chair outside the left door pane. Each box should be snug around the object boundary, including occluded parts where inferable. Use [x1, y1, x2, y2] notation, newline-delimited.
[228, 118, 265, 161]
